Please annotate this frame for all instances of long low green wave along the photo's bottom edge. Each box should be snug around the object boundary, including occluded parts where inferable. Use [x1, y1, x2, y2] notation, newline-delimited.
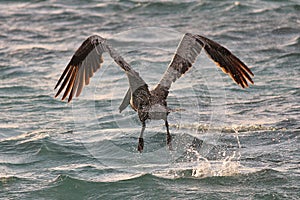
[0, 168, 297, 199]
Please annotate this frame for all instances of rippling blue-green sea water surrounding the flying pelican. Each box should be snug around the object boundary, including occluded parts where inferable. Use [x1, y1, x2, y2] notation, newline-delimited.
[0, 0, 300, 199]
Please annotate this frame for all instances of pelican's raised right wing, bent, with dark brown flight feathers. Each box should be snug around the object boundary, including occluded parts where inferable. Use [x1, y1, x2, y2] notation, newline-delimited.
[153, 33, 254, 99]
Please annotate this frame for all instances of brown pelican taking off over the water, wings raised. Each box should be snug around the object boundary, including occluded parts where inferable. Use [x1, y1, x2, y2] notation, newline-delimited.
[54, 33, 254, 152]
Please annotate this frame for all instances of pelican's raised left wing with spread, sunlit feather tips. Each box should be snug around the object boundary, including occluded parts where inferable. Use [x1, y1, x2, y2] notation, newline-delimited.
[54, 35, 143, 102]
